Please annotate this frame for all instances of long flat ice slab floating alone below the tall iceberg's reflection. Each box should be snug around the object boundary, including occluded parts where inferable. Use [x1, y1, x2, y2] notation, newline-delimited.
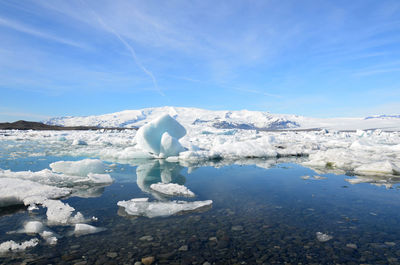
[117, 198, 212, 218]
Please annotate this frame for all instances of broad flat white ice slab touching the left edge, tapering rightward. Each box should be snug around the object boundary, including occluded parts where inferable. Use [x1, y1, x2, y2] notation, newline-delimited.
[0, 178, 71, 207]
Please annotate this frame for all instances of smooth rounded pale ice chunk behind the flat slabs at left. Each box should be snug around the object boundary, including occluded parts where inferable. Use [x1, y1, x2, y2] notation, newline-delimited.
[50, 159, 106, 176]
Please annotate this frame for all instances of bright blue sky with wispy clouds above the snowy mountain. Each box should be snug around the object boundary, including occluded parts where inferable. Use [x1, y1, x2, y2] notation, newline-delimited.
[0, 0, 400, 121]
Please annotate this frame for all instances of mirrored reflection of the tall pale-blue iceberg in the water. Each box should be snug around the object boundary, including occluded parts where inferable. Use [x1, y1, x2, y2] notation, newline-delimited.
[136, 160, 186, 195]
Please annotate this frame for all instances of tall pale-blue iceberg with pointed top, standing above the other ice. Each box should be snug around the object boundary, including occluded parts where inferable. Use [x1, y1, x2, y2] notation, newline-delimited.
[136, 114, 186, 157]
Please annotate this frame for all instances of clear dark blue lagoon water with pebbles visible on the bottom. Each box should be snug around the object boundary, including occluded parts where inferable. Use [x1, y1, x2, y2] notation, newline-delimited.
[0, 157, 400, 264]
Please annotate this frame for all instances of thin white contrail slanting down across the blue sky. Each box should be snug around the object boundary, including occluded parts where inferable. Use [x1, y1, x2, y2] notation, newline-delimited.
[81, 0, 165, 97]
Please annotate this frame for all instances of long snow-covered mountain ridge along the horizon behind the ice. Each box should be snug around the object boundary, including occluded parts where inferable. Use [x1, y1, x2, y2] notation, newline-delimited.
[44, 107, 400, 130]
